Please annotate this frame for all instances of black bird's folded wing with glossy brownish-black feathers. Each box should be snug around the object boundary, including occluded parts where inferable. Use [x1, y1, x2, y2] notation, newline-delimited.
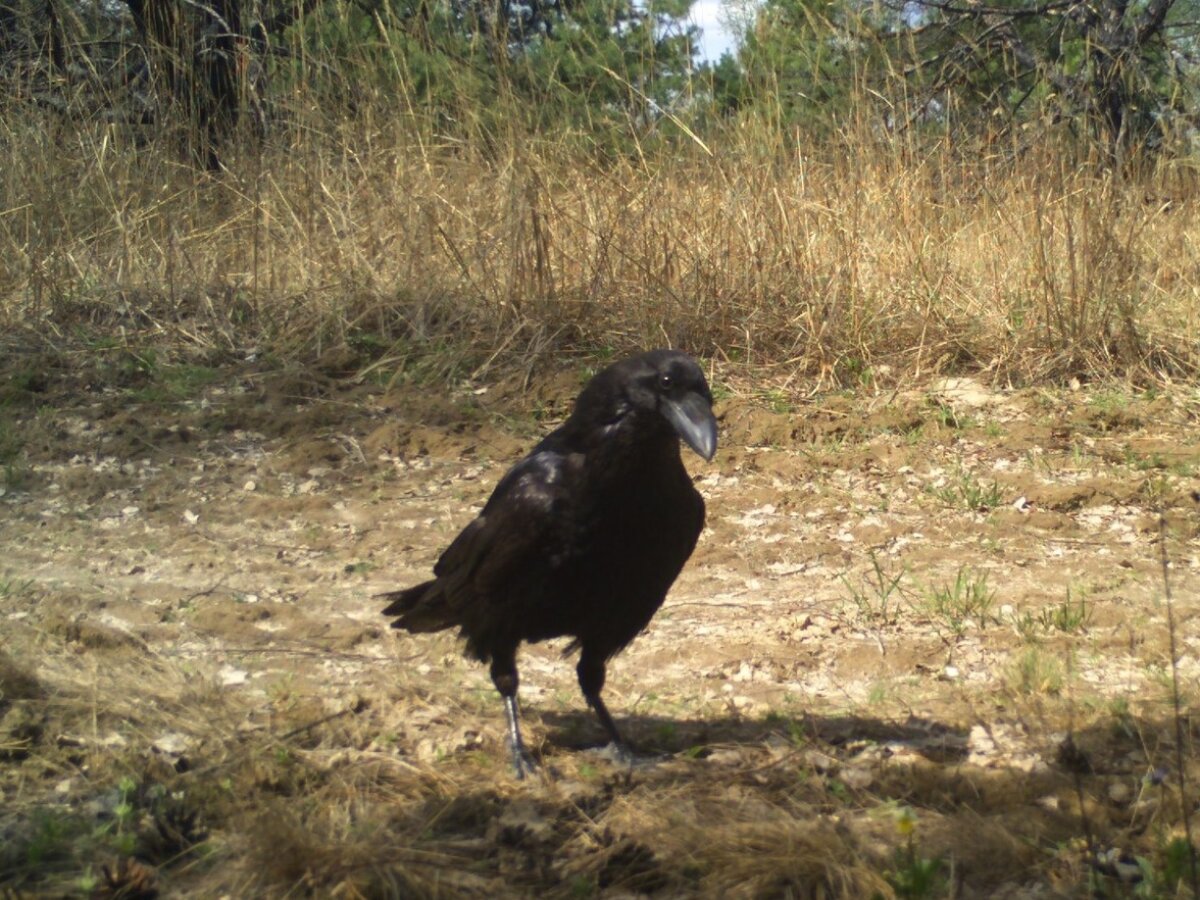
[433, 449, 581, 599]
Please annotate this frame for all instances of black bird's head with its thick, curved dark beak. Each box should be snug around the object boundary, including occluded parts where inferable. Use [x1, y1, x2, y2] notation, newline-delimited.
[576, 350, 716, 460]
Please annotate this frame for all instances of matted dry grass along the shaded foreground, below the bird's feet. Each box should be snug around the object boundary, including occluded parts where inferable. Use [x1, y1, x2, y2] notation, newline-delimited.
[7, 609, 1195, 900]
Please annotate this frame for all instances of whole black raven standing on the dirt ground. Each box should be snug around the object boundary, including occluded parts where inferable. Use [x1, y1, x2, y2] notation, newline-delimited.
[383, 350, 716, 778]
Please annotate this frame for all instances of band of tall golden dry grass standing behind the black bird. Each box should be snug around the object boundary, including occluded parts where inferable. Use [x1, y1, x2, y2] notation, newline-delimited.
[0, 62, 1200, 384]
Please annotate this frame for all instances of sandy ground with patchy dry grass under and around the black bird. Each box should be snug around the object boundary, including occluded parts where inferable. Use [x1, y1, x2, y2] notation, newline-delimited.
[0, 355, 1200, 898]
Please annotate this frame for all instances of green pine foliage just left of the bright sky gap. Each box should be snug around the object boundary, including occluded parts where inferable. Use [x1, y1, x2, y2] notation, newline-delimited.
[285, 0, 700, 149]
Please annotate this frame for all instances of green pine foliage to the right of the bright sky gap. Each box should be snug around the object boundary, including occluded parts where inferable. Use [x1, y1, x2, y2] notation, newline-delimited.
[714, 0, 1200, 161]
